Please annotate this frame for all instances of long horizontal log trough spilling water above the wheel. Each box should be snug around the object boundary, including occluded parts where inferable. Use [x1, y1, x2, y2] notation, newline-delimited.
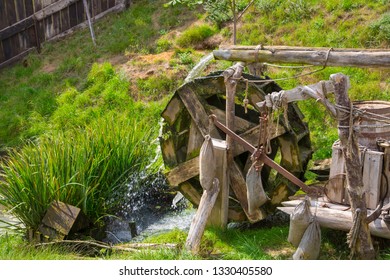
[213, 46, 390, 68]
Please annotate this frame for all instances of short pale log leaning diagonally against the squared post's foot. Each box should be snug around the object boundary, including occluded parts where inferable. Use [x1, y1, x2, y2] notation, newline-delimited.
[186, 179, 219, 254]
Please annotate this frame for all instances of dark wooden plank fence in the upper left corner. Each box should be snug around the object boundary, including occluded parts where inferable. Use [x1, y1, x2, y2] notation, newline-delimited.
[0, 0, 130, 68]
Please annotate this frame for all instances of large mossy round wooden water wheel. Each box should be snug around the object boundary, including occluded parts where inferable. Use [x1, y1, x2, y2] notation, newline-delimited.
[160, 72, 312, 222]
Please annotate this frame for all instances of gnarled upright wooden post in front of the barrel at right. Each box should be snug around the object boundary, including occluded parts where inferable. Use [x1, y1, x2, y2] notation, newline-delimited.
[330, 74, 375, 259]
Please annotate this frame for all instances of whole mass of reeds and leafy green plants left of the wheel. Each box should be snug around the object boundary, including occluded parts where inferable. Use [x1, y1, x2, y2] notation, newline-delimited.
[0, 64, 161, 232]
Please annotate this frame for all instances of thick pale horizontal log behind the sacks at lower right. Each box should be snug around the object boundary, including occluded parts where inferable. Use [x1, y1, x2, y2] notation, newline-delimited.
[278, 207, 390, 239]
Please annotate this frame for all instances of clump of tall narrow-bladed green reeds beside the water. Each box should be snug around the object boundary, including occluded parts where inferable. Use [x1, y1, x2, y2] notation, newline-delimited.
[0, 116, 156, 229]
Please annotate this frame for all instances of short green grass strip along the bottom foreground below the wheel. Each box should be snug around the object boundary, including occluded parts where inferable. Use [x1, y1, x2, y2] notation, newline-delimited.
[0, 225, 390, 260]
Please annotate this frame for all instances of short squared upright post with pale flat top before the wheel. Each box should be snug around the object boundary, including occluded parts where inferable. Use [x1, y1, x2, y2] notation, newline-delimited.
[207, 139, 229, 228]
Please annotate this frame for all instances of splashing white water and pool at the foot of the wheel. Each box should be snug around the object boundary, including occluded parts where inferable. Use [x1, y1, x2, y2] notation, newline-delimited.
[103, 173, 195, 244]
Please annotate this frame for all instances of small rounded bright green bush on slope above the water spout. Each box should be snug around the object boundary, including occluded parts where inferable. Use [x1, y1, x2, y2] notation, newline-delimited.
[176, 24, 216, 48]
